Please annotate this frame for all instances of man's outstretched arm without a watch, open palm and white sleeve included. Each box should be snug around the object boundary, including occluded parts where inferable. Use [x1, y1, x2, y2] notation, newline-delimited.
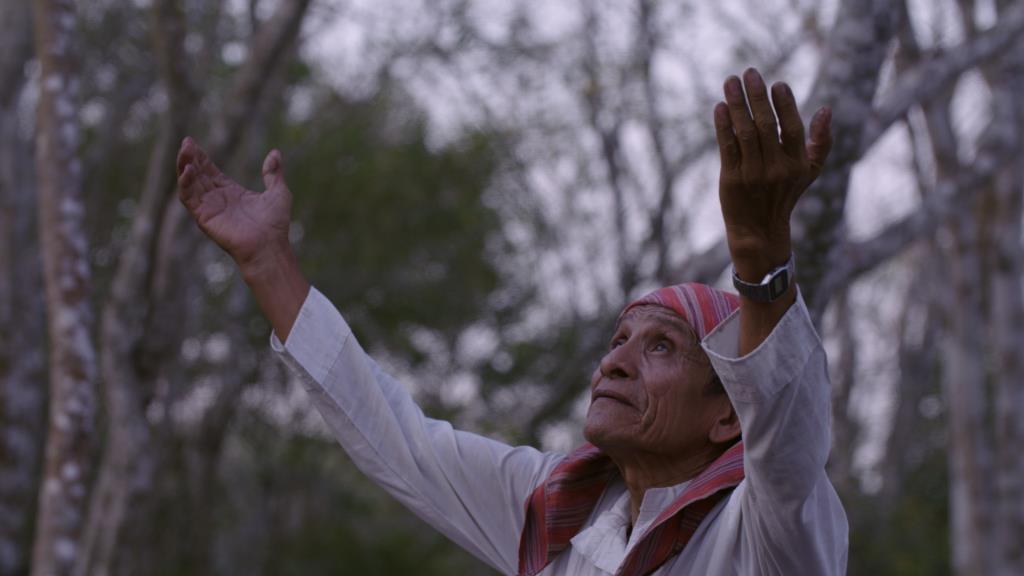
[177, 138, 562, 573]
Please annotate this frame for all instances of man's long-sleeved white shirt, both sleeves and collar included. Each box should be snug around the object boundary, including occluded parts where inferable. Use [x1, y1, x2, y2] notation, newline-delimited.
[270, 289, 848, 576]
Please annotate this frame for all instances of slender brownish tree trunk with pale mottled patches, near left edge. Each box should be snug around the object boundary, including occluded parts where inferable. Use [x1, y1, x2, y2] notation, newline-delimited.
[32, 0, 96, 576]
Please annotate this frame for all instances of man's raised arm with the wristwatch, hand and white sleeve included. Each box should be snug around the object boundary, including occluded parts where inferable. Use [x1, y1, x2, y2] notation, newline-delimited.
[703, 69, 848, 575]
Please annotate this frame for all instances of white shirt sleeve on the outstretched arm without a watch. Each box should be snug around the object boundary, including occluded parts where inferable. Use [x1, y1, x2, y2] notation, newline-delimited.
[270, 288, 563, 574]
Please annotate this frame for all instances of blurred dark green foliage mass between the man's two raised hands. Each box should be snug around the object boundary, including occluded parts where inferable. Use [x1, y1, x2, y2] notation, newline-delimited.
[276, 87, 499, 360]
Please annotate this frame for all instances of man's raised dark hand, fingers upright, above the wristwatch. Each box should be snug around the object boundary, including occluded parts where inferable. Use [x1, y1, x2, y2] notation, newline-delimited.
[715, 68, 831, 282]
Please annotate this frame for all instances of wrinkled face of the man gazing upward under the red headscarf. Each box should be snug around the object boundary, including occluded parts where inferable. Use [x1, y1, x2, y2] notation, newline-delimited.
[584, 305, 730, 455]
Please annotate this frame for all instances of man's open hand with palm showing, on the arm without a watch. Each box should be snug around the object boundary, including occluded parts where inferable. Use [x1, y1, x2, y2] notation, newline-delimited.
[177, 138, 292, 277]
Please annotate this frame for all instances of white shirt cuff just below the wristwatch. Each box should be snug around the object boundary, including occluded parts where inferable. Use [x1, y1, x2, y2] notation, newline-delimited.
[701, 289, 821, 403]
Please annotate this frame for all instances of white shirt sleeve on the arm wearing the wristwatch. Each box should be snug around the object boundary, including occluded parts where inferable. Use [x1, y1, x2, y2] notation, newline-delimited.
[703, 294, 848, 575]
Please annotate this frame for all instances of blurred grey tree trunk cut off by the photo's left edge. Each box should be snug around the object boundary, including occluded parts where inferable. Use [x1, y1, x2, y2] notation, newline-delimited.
[0, 2, 46, 576]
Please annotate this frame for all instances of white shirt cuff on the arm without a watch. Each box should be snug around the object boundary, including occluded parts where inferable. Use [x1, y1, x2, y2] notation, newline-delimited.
[270, 287, 352, 382]
